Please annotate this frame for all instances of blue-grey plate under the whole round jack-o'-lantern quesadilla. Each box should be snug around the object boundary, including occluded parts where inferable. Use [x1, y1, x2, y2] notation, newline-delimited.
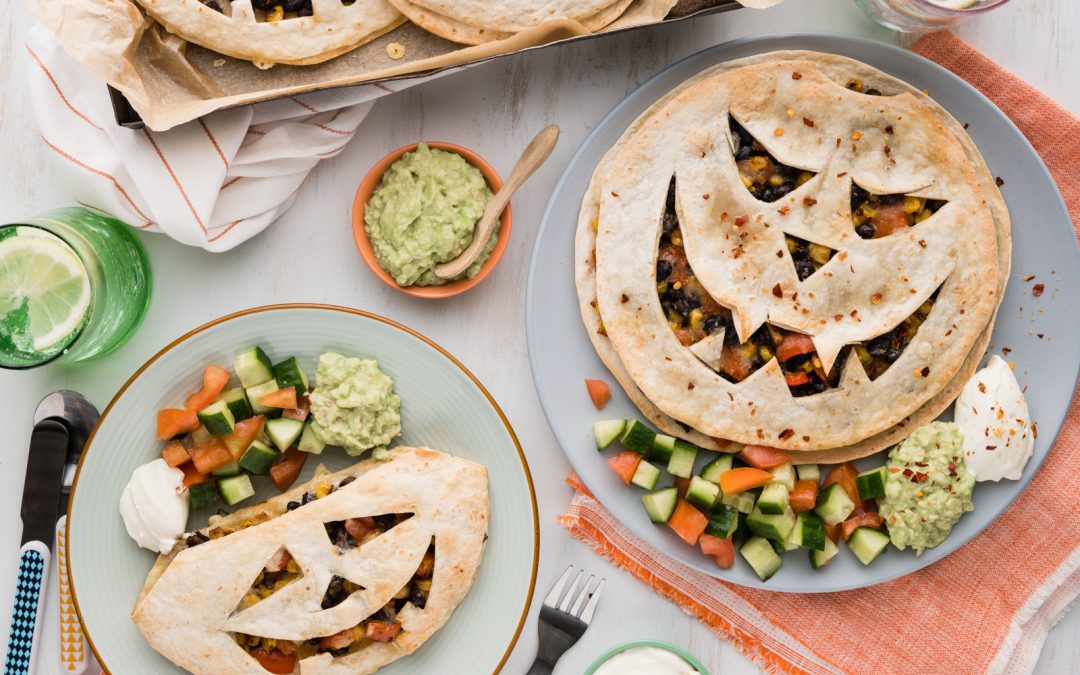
[526, 35, 1080, 593]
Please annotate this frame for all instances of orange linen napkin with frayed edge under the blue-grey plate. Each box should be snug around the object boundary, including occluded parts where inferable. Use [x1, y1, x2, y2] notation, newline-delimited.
[559, 33, 1080, 675]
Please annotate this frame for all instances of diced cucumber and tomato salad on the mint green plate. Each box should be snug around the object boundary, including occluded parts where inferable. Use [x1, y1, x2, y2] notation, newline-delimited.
[157, 346, 317, 510]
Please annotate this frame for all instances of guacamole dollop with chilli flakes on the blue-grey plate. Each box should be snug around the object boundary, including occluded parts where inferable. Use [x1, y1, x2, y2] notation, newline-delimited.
[880, 422, 975, 555]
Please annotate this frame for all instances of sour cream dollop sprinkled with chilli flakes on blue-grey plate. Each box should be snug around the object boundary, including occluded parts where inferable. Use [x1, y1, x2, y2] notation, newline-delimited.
[954, 355, 1035, 481]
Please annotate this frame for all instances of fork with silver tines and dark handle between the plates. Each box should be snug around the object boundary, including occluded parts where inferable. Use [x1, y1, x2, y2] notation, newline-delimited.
[528, 565, 604, 675]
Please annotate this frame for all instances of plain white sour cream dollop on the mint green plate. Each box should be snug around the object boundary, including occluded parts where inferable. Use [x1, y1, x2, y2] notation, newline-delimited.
[120, 459, 189, 553]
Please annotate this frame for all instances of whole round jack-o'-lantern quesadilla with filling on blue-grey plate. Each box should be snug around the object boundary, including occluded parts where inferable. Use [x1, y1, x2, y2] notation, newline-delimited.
[576, 52, 1010, 462]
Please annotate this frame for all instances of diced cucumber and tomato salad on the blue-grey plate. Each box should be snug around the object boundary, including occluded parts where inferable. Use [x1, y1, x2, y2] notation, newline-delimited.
[593, 419, 889, 581]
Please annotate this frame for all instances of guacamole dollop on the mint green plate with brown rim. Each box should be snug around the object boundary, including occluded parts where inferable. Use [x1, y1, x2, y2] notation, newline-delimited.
[309, 352, 402, 455]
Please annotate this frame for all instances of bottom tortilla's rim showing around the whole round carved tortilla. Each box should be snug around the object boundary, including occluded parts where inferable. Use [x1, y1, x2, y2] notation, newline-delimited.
[576, 52, 1011, 462]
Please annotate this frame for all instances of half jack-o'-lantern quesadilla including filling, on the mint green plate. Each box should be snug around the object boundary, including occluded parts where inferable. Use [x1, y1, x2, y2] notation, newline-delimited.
[132, 447, 488, 674]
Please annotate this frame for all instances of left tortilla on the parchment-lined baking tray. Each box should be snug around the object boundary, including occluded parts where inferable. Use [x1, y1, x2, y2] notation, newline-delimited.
[138, 0, 405, 67]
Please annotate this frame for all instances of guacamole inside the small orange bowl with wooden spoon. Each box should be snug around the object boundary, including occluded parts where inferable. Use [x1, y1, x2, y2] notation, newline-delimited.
[364, 143, 500, 286]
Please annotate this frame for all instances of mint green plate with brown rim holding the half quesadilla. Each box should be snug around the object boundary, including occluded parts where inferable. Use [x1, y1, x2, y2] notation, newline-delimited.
[67, 306, 539, 675]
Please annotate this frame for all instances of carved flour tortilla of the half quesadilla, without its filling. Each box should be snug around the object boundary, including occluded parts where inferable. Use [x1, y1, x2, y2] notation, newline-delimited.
[132, 447, 488, 675]
